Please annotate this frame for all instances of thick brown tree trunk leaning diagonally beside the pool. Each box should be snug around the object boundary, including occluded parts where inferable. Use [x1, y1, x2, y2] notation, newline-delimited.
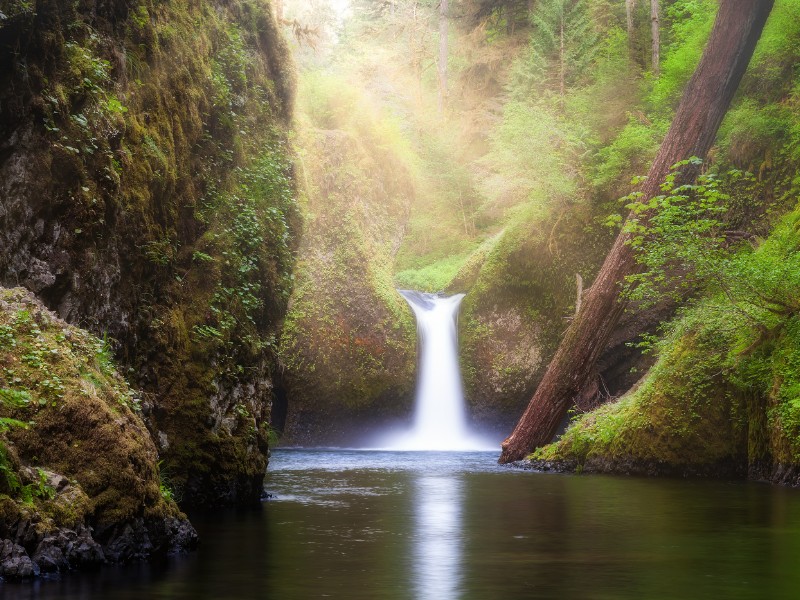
[500, 0, 773, 463]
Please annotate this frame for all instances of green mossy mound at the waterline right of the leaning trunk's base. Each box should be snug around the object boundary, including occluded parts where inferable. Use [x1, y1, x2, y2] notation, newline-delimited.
[533, 329, 748, 474]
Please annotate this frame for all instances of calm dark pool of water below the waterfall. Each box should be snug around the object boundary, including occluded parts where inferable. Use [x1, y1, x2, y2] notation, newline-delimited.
[0, 450, 800, 600]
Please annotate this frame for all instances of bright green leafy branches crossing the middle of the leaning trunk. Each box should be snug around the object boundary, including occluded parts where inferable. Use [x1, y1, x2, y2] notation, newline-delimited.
[623, 161, 800, 328]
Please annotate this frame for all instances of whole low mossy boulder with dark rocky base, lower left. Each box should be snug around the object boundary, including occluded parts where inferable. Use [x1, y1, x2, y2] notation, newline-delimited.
[0, 288, 196, 578]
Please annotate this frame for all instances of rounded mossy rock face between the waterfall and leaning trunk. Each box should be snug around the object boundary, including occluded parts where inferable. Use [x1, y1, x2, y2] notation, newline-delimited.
[456, 205, 632, 432]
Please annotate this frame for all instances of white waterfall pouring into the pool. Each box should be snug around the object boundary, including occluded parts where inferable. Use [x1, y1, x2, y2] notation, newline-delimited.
[385, 290, 496, 451]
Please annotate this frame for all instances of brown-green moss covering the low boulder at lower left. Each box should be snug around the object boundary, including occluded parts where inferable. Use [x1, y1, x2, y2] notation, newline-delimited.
[0, 288, 179, 529]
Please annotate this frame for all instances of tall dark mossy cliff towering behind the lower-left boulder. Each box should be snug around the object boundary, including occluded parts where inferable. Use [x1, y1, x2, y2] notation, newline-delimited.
[0, 0, 297, 504]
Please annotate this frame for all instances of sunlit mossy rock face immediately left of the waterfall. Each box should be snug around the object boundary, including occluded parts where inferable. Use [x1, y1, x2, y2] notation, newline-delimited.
[281, 129, 416, 443]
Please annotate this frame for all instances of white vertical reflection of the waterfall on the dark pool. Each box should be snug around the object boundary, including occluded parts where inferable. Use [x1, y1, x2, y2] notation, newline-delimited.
[412, 475, 463, 600]
